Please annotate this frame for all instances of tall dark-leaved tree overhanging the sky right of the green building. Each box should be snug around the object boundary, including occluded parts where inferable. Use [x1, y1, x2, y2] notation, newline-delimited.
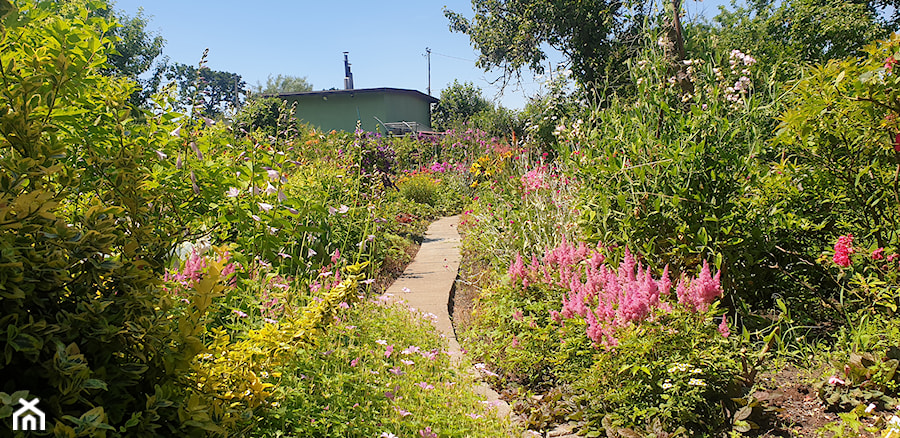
[444, 0, 648, 85]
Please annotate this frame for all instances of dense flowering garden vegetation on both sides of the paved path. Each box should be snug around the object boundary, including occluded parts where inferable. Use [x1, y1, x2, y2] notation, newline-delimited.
[0, 0, 900, 437]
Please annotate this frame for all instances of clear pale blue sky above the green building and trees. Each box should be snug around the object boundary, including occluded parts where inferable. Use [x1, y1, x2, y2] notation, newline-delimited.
[109, 0, 730, 108]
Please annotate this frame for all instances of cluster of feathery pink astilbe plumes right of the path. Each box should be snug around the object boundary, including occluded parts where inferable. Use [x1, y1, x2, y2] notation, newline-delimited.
[508, 241, 724, 348]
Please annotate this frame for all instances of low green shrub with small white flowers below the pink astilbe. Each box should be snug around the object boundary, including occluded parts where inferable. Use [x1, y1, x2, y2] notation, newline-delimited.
[575, 311, 743, 436]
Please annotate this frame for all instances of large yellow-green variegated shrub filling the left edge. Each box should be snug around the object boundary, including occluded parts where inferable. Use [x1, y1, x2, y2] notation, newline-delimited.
[0, 1, 215, 437]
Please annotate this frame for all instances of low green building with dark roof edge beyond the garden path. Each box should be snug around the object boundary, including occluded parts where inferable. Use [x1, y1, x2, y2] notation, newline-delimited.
[278, 88, 438, 133]
